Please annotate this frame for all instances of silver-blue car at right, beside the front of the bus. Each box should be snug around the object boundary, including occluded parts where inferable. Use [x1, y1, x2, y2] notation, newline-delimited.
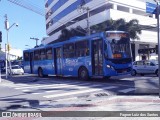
[131, 60, 158, 76]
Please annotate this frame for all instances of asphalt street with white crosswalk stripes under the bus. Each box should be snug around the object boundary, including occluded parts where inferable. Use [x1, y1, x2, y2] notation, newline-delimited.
[0, 74, 159, 110]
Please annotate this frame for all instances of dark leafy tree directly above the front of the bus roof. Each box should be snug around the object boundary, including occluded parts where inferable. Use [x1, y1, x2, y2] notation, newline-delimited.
[91, 18, 141, 39]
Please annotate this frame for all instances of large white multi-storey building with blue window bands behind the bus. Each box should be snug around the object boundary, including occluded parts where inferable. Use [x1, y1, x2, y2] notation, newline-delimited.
[42, 0, 158, 60]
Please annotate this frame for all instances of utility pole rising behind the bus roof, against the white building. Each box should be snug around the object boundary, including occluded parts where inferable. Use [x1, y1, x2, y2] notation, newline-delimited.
[77, 4, 91, 35]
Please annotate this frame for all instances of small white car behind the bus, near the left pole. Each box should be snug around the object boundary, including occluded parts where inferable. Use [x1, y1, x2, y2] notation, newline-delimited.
[8, 65, 24, 75]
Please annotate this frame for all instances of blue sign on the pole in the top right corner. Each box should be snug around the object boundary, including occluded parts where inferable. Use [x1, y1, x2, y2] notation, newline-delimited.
[146, 2, 157, 14]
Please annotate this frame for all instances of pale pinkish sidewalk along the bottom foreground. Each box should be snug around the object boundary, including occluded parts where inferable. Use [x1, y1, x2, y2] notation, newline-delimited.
[2, 96, 160, 120]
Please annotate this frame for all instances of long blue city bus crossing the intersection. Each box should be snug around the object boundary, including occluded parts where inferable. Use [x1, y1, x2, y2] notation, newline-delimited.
[23, 31, 132, 80]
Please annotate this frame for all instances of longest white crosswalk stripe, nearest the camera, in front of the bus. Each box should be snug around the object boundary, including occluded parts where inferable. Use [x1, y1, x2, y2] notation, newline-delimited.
[43, 86, 117, 98]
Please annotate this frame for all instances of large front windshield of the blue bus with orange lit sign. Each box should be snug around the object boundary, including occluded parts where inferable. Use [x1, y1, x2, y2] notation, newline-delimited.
[105, 33, 131, 59]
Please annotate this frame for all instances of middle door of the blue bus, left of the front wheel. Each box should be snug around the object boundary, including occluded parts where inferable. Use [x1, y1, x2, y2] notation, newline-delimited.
[54, 47, 62, 75]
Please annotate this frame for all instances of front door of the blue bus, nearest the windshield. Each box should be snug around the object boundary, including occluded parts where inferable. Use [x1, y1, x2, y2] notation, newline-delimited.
[92, 39, 103, 75]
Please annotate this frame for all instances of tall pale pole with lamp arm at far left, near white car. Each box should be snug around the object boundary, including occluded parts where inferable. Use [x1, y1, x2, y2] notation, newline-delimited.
[5, 14, 18, 79]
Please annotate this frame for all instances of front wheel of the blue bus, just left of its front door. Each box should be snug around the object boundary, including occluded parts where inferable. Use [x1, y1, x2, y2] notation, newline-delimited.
[78, 67, 89, 80]
